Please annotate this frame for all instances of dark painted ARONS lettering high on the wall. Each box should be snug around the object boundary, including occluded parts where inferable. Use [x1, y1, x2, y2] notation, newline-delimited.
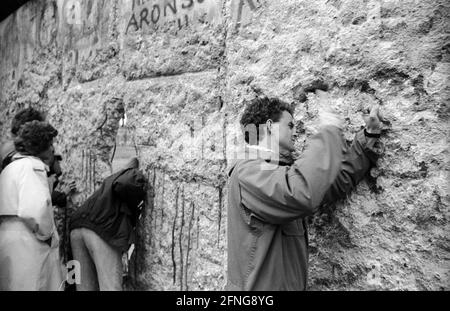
[125, 0, 220, 34]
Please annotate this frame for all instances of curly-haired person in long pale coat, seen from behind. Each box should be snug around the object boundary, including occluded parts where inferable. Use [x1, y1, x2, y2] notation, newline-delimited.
[0, 121, 63, 290]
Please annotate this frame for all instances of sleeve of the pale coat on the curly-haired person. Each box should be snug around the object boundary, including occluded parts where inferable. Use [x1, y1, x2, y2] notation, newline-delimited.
[17, 163, 55, 241]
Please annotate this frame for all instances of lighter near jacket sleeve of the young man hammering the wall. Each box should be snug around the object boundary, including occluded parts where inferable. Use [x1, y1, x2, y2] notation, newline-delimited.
[237, 126, 344, 224]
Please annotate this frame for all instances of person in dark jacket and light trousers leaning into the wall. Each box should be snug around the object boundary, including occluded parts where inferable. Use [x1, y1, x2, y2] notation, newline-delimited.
[69, 158, 147, 291]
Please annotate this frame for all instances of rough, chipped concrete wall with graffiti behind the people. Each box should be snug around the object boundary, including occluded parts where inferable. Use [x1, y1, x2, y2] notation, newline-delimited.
[0, 0, 450, 290]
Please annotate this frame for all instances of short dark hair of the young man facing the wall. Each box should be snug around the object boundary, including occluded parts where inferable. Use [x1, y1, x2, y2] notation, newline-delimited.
[240, 97, 294, 143]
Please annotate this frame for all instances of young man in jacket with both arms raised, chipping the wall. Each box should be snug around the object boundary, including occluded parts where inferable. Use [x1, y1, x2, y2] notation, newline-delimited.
[227, 98, 380, 290]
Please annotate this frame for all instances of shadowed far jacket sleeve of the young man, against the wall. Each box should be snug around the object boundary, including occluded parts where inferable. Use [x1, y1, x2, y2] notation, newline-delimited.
[321, 130, 380, 206]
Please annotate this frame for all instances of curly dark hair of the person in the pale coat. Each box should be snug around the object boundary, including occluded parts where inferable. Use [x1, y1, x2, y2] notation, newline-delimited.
[14, 120, 58, 156]
